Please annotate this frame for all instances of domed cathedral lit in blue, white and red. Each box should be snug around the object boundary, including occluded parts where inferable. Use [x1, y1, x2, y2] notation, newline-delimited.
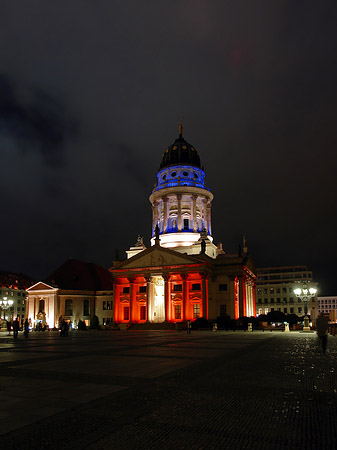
[110, 124, 256, 324]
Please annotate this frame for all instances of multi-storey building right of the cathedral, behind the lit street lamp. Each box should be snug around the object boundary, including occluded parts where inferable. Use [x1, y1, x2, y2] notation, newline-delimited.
[256, 266, 318, 320]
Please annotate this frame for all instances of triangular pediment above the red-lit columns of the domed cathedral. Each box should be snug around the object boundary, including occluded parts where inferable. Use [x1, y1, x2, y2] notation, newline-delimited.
[112, 246, 200, 271]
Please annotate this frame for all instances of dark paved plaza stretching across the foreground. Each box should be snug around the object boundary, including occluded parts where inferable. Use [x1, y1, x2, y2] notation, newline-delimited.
[0, 331, 337, 450]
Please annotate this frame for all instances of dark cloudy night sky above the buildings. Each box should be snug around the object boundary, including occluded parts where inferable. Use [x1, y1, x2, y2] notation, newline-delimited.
[0, 0, 337, 295]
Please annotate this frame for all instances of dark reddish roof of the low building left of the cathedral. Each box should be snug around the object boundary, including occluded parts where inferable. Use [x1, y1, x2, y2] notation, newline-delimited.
[44, 259, 113, 291]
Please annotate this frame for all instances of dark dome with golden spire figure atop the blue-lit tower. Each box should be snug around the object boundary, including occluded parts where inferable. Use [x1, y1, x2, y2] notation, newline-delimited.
[159, 126, 203, 170]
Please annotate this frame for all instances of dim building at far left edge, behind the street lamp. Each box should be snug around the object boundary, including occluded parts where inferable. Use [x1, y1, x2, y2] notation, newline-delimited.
[0, 272, 34, 322]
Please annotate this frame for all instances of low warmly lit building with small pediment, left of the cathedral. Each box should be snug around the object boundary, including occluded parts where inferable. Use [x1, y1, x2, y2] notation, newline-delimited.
[27, 259, 114, 328]
